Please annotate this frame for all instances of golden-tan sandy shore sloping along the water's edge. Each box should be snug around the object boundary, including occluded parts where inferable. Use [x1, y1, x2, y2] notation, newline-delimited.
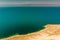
[0, 24, 60, 40]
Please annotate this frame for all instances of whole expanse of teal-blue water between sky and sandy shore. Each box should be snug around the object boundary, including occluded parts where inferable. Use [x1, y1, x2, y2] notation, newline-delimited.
[0, 7, 60, 38]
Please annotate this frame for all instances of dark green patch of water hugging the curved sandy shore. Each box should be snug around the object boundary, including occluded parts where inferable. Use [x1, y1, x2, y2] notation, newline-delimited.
[0, 24, 44, 38]
